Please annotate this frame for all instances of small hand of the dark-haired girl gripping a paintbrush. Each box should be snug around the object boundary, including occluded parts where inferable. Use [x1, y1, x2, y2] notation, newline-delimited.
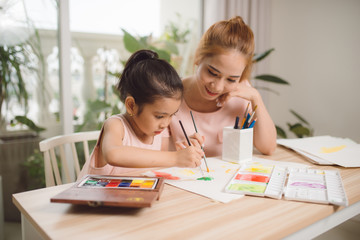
[176, 146, 204, 168]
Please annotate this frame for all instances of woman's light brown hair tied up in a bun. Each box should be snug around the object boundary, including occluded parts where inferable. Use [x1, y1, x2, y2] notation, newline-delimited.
[194, 16, 255, 81]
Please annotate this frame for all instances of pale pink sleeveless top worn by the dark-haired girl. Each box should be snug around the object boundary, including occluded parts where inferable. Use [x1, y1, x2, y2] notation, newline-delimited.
[78, 114, 165, 179]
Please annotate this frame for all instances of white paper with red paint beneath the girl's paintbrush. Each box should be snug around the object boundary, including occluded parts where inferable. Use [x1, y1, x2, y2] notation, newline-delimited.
[144, 157, 307, 203]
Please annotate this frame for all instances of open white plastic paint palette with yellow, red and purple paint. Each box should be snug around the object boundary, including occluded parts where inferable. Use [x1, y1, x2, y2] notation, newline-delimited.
[225, 163, 348, 206]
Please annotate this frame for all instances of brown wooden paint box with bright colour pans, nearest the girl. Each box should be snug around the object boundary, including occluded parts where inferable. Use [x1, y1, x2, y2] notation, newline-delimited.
[50, 175, 164, 208]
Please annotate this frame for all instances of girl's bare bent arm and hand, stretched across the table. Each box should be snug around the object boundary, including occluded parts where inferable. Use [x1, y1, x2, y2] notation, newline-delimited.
[101, 119, 203, 168]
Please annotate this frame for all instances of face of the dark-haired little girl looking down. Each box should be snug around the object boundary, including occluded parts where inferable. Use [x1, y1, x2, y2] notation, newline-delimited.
[132, 98, 181, 138]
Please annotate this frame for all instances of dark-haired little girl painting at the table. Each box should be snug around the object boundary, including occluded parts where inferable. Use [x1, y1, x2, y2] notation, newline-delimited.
[79, 50, 203, 178]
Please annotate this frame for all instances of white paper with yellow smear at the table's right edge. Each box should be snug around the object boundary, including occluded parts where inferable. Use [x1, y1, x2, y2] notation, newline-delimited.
[277, 136, 360, 167]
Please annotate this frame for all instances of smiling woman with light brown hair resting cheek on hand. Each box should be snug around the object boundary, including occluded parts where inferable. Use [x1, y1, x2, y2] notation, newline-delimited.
[170, 17, 276, 157]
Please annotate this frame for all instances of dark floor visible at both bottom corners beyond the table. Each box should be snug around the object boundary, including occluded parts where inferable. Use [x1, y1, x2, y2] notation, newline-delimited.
[0, 215, 360, 240]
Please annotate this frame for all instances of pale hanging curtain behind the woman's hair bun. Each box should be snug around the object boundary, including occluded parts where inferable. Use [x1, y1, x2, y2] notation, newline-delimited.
[203, 0, 272, 102]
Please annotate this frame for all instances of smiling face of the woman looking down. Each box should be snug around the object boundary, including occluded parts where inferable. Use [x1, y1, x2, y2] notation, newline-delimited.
[196, 50, 246, 101]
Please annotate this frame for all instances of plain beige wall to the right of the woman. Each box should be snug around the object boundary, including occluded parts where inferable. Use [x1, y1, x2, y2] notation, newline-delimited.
[266, 0, 360, 143]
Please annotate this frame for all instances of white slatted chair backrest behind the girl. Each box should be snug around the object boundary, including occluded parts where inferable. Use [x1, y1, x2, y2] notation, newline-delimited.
[39, 131, 100, 187]
